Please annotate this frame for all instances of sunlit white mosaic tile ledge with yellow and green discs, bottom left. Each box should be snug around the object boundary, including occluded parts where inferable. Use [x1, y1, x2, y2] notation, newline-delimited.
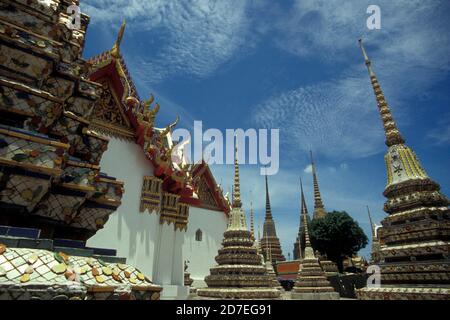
[0, 244, 161, 300]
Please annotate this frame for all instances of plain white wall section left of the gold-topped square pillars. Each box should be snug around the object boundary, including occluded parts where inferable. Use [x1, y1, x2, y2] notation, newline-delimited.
[87, 138, 159, 278]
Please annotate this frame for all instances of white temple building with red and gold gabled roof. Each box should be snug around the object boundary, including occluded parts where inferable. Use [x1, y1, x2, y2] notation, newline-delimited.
[82, 24, 230, 299]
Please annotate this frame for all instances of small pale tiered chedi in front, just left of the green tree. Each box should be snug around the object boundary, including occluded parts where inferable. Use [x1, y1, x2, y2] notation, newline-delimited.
[291, 205, 339, 300]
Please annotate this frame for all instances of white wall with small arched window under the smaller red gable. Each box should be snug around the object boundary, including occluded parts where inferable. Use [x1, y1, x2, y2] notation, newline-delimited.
[183, 207, 228, 287]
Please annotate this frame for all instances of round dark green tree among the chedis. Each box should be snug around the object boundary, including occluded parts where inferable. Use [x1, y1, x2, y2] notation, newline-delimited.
[309, 211, 368, 272]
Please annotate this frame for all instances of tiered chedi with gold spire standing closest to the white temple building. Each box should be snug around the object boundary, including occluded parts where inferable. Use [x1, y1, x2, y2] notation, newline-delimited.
[197, 141, 280, 299]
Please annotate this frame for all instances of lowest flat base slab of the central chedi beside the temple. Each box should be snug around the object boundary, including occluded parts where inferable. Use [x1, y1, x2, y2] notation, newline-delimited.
[197, 287, 281, 300]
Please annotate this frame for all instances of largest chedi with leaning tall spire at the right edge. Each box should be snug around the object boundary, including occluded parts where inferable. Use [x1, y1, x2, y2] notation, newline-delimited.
[358, 40, 450, 300]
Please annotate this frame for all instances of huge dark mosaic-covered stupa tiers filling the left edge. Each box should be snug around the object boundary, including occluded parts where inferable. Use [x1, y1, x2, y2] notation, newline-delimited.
[0, 0, 161, 299]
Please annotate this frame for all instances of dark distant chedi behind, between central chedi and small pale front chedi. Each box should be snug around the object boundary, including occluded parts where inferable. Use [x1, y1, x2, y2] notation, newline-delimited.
[261, 175, 286, 262]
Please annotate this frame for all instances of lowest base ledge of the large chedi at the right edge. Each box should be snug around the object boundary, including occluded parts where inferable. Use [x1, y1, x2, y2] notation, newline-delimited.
[356, 286, 450, 300]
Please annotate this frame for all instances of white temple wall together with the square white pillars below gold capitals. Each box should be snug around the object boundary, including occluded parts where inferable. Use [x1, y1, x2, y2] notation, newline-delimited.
[87, 138, 188, 299]
